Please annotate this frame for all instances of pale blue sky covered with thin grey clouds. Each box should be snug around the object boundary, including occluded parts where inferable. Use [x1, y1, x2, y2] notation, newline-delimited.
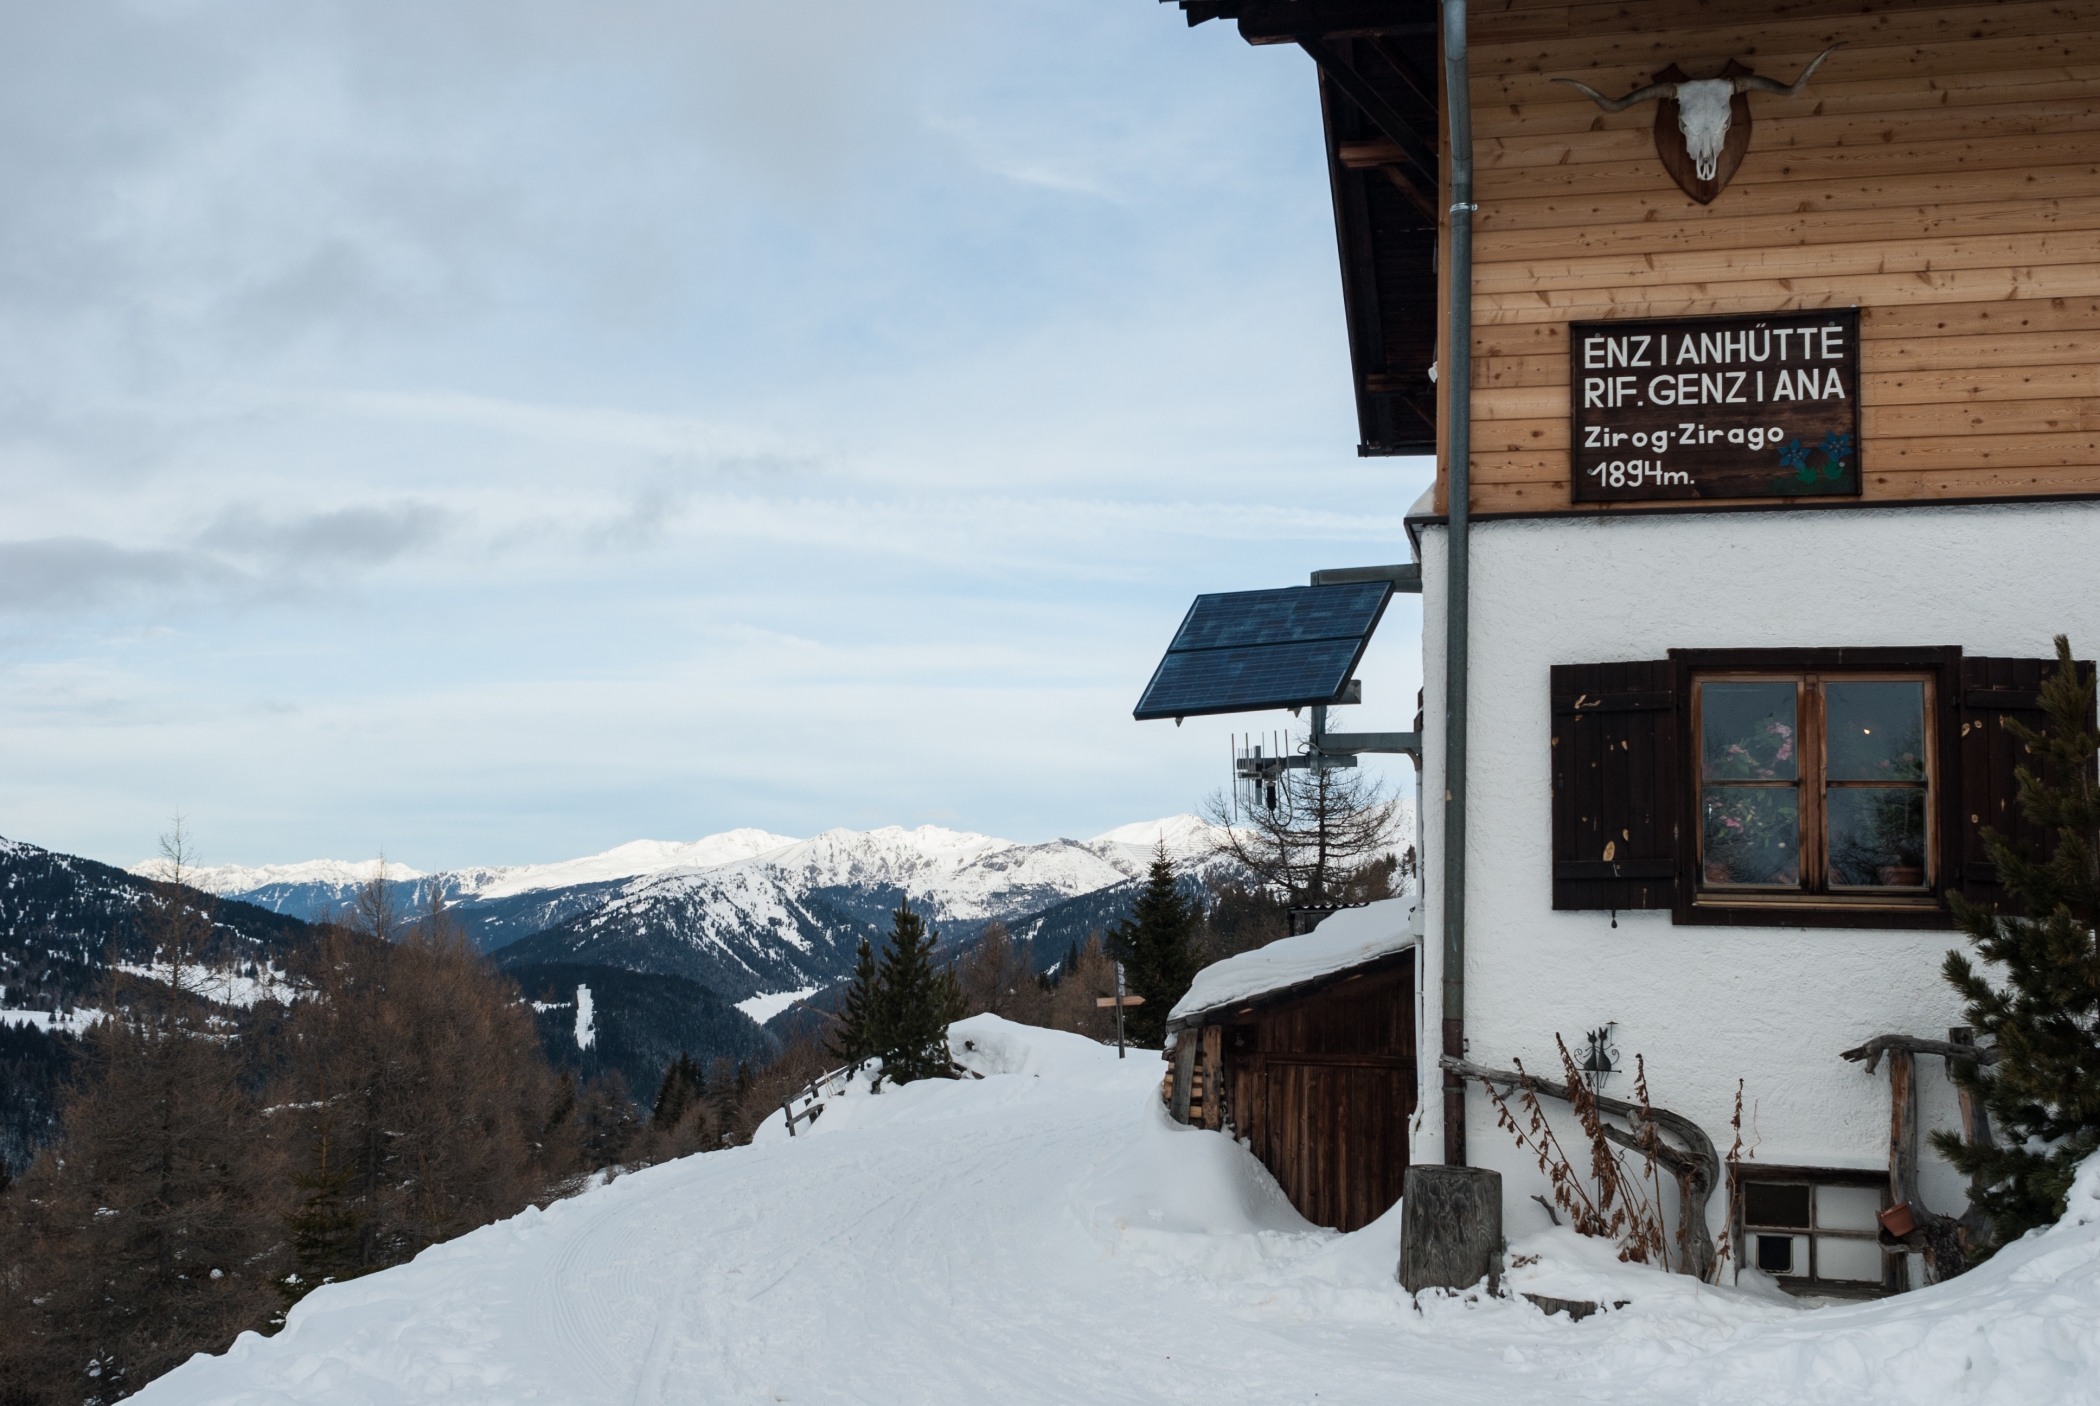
[0, 0, 1428, 869]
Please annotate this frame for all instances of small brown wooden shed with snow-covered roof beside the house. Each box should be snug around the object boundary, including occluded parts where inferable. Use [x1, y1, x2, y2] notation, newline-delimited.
[1168, 914, 1418, 1230]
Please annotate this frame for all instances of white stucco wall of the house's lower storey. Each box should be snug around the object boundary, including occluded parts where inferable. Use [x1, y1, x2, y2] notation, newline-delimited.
[1415, 504, 2100, 1236]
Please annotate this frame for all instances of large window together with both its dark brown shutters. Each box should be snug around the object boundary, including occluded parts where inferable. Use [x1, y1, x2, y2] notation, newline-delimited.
[1552, 648, 2054, 928]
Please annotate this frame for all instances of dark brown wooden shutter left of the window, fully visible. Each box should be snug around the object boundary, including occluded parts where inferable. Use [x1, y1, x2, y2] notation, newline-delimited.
[1552, 659, 1684, 909]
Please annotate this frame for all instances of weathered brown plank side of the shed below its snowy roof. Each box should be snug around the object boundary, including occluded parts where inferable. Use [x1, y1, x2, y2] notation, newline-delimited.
[1229, 957, 1415, 1230]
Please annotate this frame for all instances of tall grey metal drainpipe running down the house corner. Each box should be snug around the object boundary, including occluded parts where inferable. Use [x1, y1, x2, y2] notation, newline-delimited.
[1443, 0, 1474, 1167]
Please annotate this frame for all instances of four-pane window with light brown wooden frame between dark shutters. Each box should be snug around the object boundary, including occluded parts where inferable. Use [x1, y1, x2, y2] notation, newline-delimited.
[1693, 674, 1936, 904]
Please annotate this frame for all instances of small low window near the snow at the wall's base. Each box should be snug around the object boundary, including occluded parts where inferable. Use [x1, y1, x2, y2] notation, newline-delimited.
[1739, 1173, 1892, 1295]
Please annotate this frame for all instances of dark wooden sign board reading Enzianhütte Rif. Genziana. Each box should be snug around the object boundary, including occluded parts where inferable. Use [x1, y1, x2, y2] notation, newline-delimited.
[1569, 308, 1861, 504]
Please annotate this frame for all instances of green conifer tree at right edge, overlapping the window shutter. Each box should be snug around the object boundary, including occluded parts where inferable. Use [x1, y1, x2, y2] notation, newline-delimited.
[1932, 636, 2100, 1244]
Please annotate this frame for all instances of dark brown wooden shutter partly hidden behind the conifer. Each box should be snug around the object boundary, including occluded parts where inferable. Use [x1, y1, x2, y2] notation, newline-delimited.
[1947, 657, 2092, 909]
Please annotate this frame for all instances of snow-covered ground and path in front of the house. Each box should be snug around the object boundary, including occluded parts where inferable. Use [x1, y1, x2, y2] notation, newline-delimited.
[137, 1016, 2100, 1406]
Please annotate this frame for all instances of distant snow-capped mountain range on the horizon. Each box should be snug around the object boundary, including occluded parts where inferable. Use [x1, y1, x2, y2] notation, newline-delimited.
[134, 814, 1243, 1001]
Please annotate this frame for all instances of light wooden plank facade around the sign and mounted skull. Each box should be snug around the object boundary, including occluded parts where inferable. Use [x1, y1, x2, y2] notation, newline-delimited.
[1444, 0, 2100, 514]
